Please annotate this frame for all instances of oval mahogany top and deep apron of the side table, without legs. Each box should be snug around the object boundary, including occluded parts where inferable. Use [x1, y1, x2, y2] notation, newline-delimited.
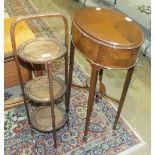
[72, 7, 144, 68]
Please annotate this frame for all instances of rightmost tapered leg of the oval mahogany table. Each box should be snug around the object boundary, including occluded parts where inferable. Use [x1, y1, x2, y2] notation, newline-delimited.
[113, 67, 134, 130]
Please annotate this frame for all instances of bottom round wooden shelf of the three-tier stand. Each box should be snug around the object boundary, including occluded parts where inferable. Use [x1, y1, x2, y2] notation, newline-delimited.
[31, 105, 67, 132]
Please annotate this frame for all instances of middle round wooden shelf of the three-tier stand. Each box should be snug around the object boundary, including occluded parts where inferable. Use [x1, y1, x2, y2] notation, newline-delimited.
[24, 76, 67, 103]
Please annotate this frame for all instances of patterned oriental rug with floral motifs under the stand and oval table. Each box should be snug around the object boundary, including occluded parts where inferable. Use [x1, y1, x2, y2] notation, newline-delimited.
[4, 0, 143, 155]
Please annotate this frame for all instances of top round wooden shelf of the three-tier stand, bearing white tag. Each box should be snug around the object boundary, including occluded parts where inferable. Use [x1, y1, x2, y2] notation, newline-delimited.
[18, 38, 66, 64]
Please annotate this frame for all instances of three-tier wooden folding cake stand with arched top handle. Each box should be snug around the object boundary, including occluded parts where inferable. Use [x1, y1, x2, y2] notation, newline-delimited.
[10, 13, 69, 148]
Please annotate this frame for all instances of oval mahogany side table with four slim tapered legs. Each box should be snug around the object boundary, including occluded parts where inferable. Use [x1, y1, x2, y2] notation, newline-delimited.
[68, 7, 144, 138]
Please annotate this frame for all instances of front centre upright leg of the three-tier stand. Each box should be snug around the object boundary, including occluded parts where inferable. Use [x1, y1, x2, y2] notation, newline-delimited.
[48, 62, 57, 148]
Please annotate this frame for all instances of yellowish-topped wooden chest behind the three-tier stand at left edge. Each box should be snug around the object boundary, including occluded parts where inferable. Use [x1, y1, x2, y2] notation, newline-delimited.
[4, 17, 35, 88]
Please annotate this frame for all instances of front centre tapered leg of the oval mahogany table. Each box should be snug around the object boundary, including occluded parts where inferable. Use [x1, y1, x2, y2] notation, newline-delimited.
[84, 64, 98, 141]
